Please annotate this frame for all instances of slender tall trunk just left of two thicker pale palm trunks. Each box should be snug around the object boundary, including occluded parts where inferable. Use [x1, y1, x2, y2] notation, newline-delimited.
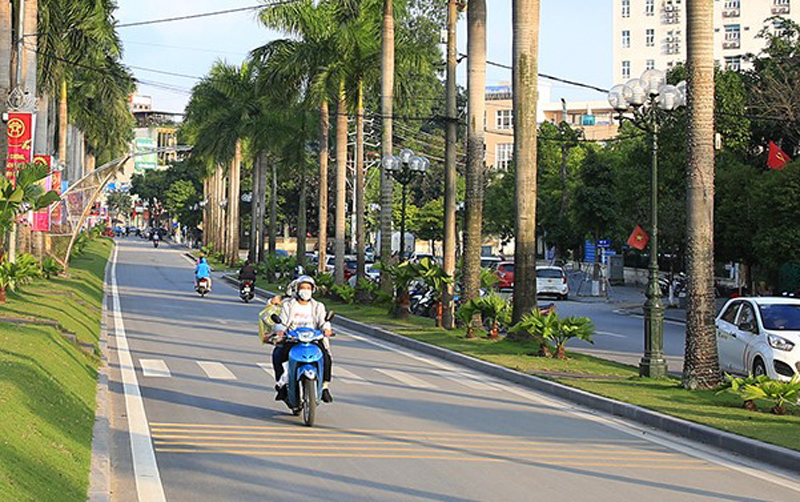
[442, 0, 458, 329]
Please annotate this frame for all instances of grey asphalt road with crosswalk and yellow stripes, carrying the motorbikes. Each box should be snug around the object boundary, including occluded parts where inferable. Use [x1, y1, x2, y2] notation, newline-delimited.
[109, 240, 800, 502]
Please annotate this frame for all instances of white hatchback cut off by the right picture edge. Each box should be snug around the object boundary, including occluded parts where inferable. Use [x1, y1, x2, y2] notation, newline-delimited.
[716, 297, 800, 380]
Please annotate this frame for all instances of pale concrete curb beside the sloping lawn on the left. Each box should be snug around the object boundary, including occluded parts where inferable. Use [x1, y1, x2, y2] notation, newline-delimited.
[86, 244, 116, 502]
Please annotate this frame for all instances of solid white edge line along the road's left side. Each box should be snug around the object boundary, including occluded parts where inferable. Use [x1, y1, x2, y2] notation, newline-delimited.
[111, 247, 167, 502]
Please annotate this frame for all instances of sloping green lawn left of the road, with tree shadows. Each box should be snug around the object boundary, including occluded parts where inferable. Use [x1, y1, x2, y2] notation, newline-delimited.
[0, 239, 112, 502]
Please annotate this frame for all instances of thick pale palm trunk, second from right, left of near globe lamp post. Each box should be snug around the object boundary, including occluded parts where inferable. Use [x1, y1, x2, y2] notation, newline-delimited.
[512, 0, 539, 322]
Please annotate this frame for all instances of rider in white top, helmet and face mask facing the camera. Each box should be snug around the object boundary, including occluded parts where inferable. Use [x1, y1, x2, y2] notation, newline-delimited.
[272, 275, 333, 403]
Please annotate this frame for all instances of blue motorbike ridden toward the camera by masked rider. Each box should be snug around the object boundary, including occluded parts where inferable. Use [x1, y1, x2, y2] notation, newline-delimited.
[271, 312, 334, 427]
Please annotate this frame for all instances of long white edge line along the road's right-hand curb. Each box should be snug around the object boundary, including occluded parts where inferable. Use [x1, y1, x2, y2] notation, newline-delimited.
[337, 328, 800, 492]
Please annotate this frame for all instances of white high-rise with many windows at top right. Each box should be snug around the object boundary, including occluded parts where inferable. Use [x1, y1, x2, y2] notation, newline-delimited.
[612, 0, 800, 83]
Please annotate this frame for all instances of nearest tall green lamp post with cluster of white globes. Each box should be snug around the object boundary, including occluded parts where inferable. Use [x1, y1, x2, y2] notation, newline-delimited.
[608, 69, 686, 378]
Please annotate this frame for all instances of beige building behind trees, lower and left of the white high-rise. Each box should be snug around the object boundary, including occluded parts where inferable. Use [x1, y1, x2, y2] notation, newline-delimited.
[485, 81, 619, 169]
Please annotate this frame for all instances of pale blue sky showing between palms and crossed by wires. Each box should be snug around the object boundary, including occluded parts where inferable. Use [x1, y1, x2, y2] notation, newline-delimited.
[117, 0, 612, 111]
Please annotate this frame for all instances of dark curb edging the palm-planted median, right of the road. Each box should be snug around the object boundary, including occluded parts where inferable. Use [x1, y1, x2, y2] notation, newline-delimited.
[223, 275, 800, 474]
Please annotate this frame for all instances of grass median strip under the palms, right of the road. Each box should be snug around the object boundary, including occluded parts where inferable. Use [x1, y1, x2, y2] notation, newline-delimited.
[263, 284, 800, 450]
